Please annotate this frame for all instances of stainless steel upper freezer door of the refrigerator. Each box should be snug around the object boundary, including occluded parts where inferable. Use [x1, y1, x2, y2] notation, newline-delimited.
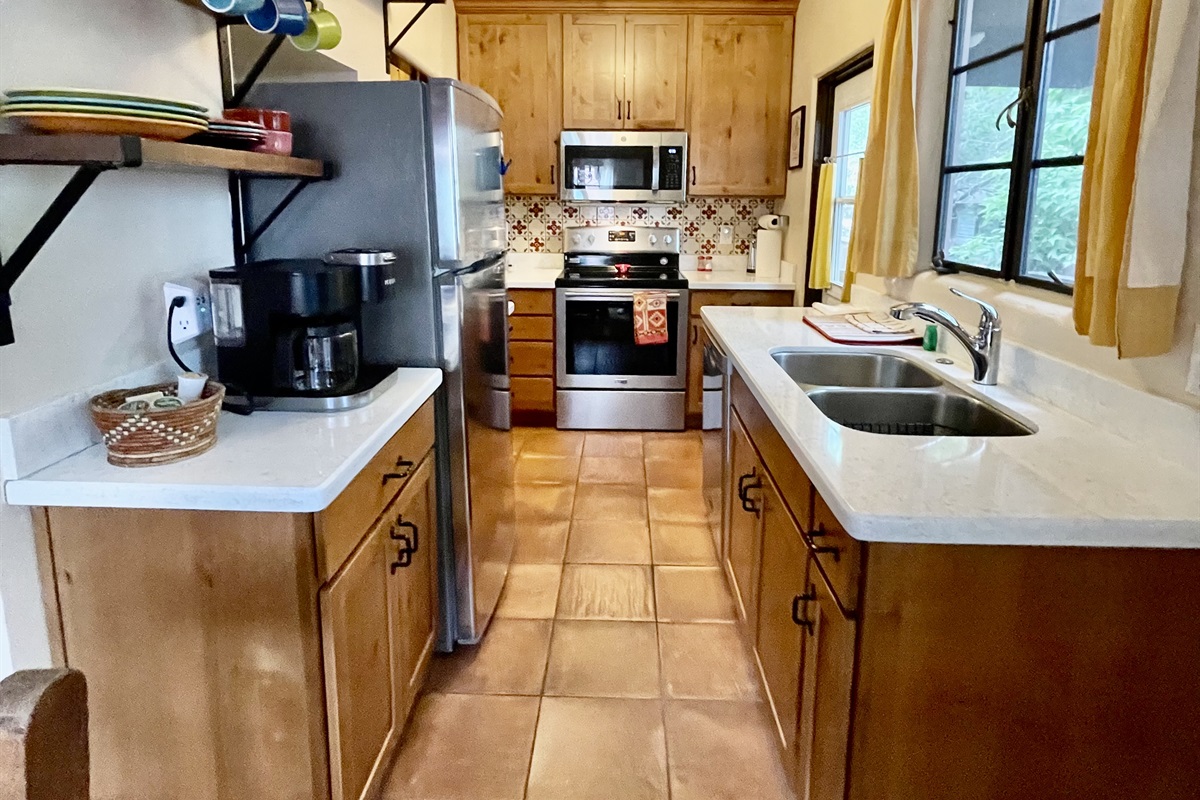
[428, 79, 508, 272]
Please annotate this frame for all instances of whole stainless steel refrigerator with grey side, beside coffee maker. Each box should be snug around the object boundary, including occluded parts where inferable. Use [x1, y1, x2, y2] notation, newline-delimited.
[245, 80, 516, 650]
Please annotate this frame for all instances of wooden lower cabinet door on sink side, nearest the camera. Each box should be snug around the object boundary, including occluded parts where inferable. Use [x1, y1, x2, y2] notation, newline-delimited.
[794, 555, 856, 800]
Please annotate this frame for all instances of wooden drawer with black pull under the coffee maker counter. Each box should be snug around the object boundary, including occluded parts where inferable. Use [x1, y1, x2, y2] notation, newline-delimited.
[317, 397, 433, 583]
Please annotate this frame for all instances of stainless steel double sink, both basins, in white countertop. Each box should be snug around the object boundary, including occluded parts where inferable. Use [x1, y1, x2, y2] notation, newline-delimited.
[772, 349, 1036, 437]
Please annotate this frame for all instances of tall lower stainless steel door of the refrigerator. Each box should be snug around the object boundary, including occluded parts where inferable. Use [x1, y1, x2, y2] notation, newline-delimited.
[438, 255, 516, 644]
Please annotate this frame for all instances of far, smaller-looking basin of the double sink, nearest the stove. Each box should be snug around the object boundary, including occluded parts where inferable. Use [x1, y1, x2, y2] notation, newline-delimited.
[772, 350, 942, 389]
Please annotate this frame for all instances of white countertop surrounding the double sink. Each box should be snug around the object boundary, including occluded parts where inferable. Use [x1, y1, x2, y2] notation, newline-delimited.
[702, 307, 1200, 548]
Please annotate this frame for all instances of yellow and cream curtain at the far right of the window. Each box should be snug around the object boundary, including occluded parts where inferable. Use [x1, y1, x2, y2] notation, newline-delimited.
[1074, 0, 1198, 359]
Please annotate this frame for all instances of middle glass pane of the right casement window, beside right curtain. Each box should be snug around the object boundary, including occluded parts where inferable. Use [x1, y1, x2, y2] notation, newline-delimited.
[1037, 25, 1099, 158]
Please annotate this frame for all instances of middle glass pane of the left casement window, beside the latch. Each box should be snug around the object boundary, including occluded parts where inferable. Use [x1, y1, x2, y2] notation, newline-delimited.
[948, 53, 1021, 164]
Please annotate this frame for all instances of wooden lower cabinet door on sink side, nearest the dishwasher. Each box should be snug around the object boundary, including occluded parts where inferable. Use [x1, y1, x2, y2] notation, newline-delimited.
[725, 414, 766, 639]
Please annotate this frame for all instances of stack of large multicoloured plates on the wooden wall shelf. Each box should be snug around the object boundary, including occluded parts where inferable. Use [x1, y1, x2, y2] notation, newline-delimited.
[0, 86, 209, 139]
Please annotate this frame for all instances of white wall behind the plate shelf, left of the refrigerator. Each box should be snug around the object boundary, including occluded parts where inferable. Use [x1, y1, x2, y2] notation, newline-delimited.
[0, 0, 233, 669]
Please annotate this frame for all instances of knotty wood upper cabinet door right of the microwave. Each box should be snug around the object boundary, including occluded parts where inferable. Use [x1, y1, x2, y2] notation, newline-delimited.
[688, 14, 792, 197]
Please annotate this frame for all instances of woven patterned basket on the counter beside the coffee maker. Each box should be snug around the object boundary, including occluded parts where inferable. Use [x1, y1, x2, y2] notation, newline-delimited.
[90, 380, 224, 467]
